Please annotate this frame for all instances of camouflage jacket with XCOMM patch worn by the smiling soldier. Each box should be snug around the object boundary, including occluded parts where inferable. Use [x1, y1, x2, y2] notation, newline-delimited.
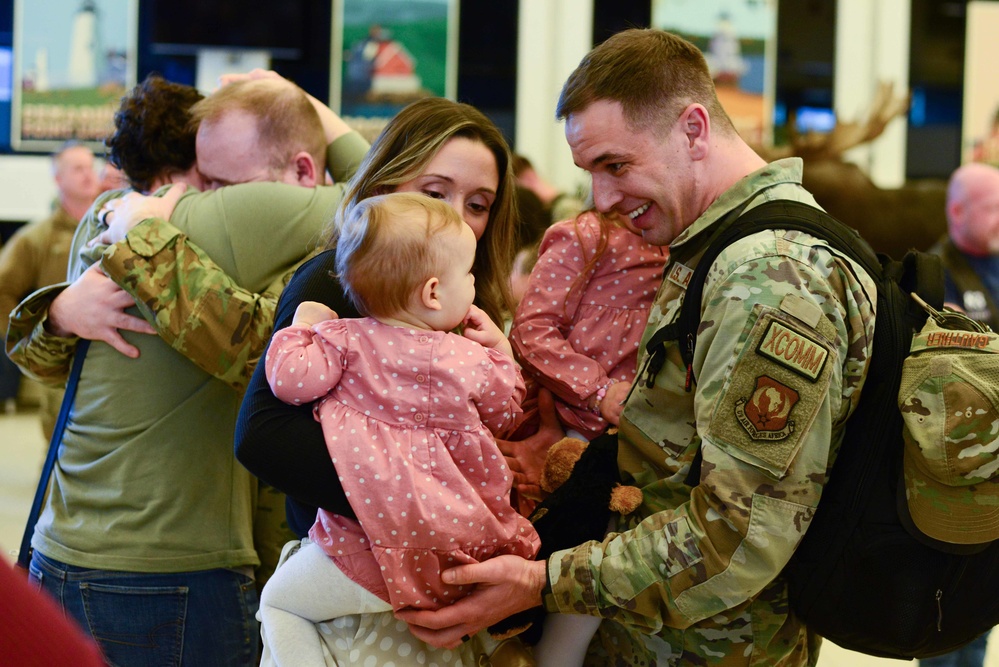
[545, 159, 876, 667]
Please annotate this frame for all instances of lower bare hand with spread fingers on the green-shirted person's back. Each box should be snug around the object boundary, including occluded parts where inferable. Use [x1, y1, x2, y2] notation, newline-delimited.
[45, 264, 156, 359]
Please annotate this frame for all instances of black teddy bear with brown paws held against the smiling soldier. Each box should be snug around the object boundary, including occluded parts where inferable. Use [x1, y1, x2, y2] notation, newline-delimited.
[489, 429, 642, 645]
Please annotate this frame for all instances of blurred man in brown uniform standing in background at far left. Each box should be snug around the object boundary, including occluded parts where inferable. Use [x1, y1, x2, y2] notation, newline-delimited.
[0, 142, 100, 440]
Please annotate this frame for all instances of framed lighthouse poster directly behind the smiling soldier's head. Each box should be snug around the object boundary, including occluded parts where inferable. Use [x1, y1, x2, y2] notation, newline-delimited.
[652, 0, 777, 146]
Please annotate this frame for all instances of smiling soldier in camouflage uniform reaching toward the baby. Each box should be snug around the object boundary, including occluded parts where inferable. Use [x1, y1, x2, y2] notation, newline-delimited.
[401, 30, 876, 666]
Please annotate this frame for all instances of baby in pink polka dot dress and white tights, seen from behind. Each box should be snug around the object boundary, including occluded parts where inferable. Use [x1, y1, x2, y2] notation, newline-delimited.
[260, 193, 539, 666]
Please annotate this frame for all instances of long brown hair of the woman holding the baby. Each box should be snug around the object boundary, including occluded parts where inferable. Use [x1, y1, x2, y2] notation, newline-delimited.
[327, 97, 517, 322]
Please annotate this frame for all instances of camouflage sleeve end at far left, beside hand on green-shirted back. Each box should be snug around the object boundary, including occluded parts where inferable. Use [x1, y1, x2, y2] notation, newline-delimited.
[7, 283, 79, 385]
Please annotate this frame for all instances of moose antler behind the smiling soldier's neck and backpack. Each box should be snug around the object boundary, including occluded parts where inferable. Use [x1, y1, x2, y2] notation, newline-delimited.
[757, 82, 911, 161]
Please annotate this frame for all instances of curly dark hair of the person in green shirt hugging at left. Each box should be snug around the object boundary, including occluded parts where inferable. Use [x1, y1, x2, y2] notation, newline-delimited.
[104, 74, 204, 192]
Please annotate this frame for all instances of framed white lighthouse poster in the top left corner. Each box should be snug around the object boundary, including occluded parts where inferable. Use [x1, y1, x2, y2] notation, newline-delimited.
[11, 0, 138, 152]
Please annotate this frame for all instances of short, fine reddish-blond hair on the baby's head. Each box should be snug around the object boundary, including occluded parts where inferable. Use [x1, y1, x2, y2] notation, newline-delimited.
[336, 192, 465, 317]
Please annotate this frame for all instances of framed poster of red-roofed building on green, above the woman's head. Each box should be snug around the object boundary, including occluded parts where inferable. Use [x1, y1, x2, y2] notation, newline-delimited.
[330, 0, 458, 134]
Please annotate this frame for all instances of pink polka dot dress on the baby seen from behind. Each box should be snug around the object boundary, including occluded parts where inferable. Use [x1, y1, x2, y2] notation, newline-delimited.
[265, 318, 539, 609]
